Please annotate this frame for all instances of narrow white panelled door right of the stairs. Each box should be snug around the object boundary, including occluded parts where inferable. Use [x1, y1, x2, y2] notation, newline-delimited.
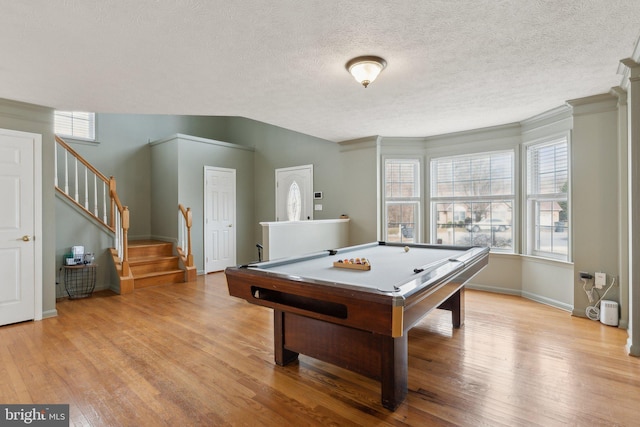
[204, 166, 236, 273]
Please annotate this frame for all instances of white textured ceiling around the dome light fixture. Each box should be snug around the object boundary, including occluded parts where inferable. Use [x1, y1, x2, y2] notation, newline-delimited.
[0, 0, 640, 141]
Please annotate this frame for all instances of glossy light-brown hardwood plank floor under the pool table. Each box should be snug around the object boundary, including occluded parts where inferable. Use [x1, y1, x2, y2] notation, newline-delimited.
[0, 273, 640, 426]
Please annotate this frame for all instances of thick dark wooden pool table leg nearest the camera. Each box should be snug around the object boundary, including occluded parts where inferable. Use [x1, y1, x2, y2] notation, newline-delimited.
[380, 333, 409, 411]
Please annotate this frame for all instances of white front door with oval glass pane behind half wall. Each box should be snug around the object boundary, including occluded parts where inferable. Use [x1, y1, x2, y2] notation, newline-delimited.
[276, 165, 313, 221]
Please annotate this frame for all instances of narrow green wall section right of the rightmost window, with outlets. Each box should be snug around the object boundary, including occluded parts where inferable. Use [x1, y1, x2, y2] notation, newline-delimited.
[571, 95, 629, 325]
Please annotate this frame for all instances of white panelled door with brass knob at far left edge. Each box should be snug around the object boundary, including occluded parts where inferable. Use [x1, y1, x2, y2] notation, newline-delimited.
[0, 129, 42, 325]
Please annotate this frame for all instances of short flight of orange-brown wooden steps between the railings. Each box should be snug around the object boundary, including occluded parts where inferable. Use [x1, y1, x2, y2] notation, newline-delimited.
[129, 240, 185, 289]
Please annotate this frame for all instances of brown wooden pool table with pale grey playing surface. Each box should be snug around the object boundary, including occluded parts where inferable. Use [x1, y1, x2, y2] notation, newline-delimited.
[225, 242, 489, 411]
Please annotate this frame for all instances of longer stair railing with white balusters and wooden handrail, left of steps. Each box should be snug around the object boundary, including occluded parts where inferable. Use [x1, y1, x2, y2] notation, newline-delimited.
[54, 135, 130, 276]
